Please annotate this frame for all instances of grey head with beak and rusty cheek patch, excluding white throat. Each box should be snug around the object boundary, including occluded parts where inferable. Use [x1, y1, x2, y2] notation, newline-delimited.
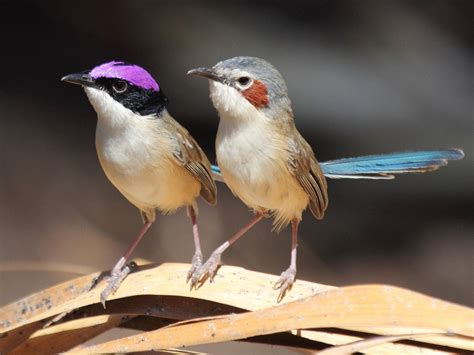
[188, 56, 293, 118]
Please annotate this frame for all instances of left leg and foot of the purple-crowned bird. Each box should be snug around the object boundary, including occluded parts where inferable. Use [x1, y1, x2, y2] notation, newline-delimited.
[100, 217, 153, 308]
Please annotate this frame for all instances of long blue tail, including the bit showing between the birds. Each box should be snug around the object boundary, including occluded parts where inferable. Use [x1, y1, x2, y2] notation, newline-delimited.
[212, 149, 464, 181]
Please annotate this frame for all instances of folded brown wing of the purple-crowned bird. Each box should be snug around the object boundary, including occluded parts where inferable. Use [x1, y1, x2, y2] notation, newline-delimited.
[173, 121, 217, 205]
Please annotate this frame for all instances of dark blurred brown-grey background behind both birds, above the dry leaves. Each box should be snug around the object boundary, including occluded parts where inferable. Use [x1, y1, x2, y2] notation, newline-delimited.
[0, 0, 474, 340]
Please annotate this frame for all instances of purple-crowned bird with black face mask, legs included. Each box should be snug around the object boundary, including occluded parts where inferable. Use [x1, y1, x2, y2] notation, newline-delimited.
[61, 61, 217, 306]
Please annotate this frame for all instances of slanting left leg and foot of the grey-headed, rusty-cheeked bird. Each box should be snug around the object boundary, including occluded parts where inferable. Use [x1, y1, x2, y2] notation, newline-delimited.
[191, 212, 265, 289]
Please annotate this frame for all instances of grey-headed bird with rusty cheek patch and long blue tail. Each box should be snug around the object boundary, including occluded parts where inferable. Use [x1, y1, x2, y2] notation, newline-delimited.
[188, 57, 463, 300]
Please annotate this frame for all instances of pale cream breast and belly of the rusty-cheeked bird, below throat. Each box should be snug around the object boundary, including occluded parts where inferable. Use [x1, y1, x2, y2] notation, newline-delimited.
[216, 122, 309, 225]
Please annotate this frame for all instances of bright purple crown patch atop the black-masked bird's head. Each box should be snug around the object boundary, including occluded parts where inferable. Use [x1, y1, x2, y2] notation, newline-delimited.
[89, 61, 160, 91]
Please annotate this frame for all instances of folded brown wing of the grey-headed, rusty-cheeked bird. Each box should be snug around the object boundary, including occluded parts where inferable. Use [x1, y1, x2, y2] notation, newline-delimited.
[288, 129, 328, 219]
